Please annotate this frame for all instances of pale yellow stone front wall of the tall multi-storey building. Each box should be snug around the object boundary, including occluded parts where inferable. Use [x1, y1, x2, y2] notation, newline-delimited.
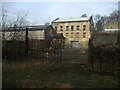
[52, 21, 91, 48]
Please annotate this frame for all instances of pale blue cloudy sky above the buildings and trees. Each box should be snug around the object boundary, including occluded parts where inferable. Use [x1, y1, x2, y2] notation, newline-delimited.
[2, 2, 118, 24]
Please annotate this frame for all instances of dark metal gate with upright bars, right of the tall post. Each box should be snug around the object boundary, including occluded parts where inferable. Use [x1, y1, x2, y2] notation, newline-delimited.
[28, 40, 62, 61]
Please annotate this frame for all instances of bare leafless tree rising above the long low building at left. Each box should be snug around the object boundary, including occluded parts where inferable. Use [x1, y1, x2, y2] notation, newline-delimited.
[2, 10, 29, 40]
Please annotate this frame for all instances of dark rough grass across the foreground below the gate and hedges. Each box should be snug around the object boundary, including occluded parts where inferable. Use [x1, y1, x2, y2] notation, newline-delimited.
[2, 61, 117, 88]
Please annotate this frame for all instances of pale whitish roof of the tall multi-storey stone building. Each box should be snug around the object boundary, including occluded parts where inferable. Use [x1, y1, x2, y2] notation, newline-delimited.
[53, 17, 91, 23]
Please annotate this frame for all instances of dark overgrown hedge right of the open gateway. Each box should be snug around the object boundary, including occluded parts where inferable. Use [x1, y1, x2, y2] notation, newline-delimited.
[89, 44, 120, 75]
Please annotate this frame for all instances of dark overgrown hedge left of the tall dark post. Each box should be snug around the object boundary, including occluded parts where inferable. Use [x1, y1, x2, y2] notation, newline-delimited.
[2, 41, 26, 61]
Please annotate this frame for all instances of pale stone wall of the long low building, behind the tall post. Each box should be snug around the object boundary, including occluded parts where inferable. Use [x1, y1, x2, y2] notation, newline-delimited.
[2, 30, 45, 40]
